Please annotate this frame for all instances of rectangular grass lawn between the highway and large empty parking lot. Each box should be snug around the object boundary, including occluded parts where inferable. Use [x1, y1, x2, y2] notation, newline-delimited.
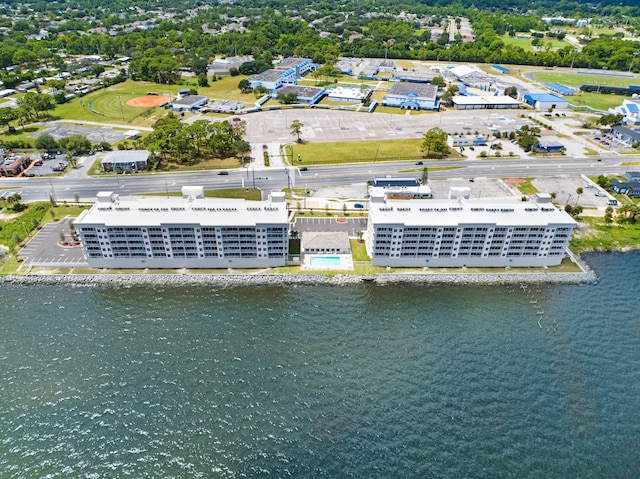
[292, 139, 422, 166]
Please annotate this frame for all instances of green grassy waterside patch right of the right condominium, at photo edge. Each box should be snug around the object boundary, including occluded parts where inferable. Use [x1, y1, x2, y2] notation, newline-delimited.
[571, 217, 640, 252]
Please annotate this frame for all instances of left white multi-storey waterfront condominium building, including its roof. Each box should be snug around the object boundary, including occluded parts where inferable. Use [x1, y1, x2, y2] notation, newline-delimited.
[74, 187, 289, 269]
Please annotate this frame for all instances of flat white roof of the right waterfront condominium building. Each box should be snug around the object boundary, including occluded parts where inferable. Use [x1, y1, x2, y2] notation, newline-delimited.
[369, 199, 576, 226]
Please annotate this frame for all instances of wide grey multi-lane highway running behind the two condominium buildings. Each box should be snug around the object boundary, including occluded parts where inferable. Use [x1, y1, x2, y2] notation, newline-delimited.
[0, 156, 640, 202]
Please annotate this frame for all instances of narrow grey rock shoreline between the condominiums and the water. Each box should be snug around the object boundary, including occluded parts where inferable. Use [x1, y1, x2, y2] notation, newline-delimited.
[0, 266, 598, 287]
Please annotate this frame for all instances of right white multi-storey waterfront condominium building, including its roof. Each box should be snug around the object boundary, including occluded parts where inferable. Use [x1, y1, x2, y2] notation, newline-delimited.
[365, 196, 576, 267]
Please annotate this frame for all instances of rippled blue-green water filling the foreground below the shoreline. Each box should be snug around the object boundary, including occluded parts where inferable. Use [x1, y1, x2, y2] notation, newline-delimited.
[0, 253, 640, 478]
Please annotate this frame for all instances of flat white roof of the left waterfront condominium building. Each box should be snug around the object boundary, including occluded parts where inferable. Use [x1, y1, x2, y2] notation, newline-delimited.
[74, 192, 287, 227]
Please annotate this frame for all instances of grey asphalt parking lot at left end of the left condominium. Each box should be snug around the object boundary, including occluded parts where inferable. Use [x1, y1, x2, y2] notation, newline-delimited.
[18, 218, 87, 268]
